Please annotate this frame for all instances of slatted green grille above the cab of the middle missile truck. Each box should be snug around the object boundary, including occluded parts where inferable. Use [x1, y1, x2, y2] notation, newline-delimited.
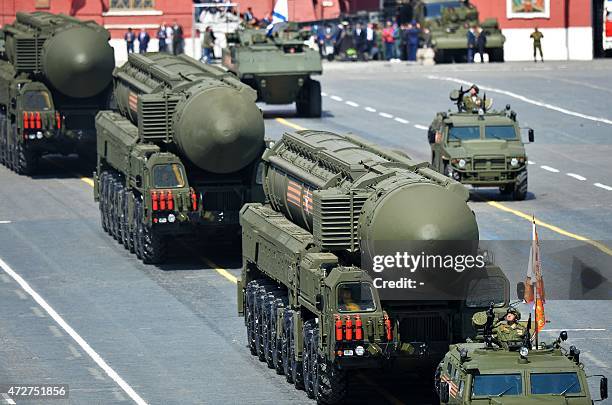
[138, 96, 179, 142]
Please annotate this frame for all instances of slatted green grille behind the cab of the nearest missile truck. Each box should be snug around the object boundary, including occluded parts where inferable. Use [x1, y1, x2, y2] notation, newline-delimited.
[312, 193, 368, 252]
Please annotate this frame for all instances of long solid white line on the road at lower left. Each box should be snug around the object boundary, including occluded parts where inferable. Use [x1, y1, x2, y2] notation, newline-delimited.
[0, 259, 147, 405]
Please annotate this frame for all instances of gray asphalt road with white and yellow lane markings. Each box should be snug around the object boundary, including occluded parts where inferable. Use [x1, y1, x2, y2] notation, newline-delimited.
[0, 61, 612, 404]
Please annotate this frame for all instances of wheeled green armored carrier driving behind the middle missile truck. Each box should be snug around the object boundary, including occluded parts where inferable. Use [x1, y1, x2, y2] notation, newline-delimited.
[223, 29, 323, 117]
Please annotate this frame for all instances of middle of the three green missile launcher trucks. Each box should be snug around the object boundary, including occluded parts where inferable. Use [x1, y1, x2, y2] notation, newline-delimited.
[94, 53, 265, 263]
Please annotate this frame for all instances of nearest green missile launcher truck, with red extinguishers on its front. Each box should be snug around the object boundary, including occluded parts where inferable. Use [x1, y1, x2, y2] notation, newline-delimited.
[238, 130, 508, 403]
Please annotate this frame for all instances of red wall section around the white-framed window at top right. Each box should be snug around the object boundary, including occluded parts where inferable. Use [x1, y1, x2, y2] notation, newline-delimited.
[471, 0, 591, 28]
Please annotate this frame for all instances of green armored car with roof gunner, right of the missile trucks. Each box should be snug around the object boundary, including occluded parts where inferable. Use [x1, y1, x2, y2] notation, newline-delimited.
[428, 86, 534, 200]
